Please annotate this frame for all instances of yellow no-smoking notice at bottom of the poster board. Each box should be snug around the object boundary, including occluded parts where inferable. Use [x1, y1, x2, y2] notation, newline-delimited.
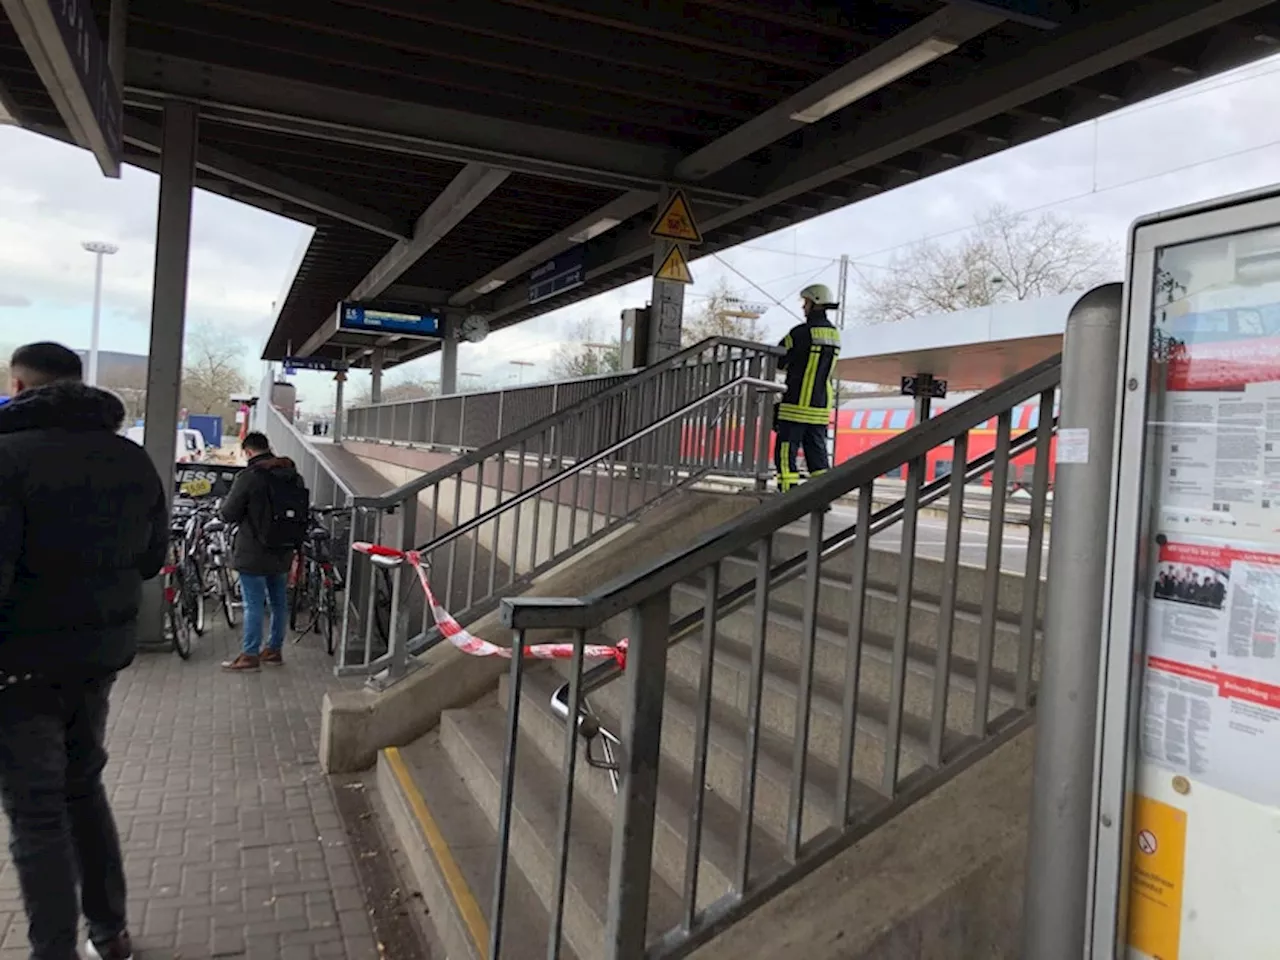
[1129, 796, 1187, 960]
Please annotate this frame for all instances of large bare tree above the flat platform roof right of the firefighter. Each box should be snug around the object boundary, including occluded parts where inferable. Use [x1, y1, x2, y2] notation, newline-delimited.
[856, 206, 1120, 324]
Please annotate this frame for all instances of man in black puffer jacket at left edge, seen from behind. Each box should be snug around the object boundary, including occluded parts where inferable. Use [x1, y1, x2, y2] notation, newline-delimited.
[0, 343, 169, 960]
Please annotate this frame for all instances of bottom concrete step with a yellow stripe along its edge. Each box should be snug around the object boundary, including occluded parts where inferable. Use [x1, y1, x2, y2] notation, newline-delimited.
[376, 732, 577, 960]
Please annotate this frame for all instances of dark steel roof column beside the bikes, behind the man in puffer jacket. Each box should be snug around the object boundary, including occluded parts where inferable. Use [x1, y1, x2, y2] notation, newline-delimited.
[140, 100, 200, 641]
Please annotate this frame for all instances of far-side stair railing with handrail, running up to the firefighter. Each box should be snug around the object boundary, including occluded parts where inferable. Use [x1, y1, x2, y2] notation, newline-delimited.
[338, 338, 781, 685]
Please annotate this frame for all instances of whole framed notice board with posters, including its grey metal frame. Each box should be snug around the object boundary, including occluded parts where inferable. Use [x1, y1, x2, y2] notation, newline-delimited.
[1091, 185, 1280, 960]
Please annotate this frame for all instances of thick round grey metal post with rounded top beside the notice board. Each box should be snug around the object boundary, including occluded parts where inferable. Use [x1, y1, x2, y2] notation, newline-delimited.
[1019, 283, 1123, 960]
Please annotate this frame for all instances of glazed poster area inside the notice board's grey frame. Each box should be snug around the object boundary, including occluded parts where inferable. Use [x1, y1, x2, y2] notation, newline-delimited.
[1125, 221, 1280, 957]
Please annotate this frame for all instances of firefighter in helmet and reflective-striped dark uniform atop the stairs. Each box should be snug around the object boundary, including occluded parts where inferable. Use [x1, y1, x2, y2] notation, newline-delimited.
[773, 283, 840, 493]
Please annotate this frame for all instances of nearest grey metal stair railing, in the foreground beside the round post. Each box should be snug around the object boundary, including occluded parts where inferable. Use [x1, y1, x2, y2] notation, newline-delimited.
[489, 357, 1061, 960]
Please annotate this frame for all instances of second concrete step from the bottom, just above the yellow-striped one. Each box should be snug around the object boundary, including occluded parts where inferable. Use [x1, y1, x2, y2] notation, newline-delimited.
[440, 698, 680, 957]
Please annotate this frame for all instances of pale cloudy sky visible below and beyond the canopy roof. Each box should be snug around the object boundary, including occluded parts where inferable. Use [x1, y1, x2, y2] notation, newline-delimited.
[0, 58, 1280, 402]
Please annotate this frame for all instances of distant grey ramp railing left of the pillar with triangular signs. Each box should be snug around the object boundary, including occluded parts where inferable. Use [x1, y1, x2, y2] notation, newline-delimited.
[343, 371, 635, 449]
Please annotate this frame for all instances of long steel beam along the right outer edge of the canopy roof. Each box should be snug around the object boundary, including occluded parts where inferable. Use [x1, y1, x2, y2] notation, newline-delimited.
[485, 0, 1272, 319]
